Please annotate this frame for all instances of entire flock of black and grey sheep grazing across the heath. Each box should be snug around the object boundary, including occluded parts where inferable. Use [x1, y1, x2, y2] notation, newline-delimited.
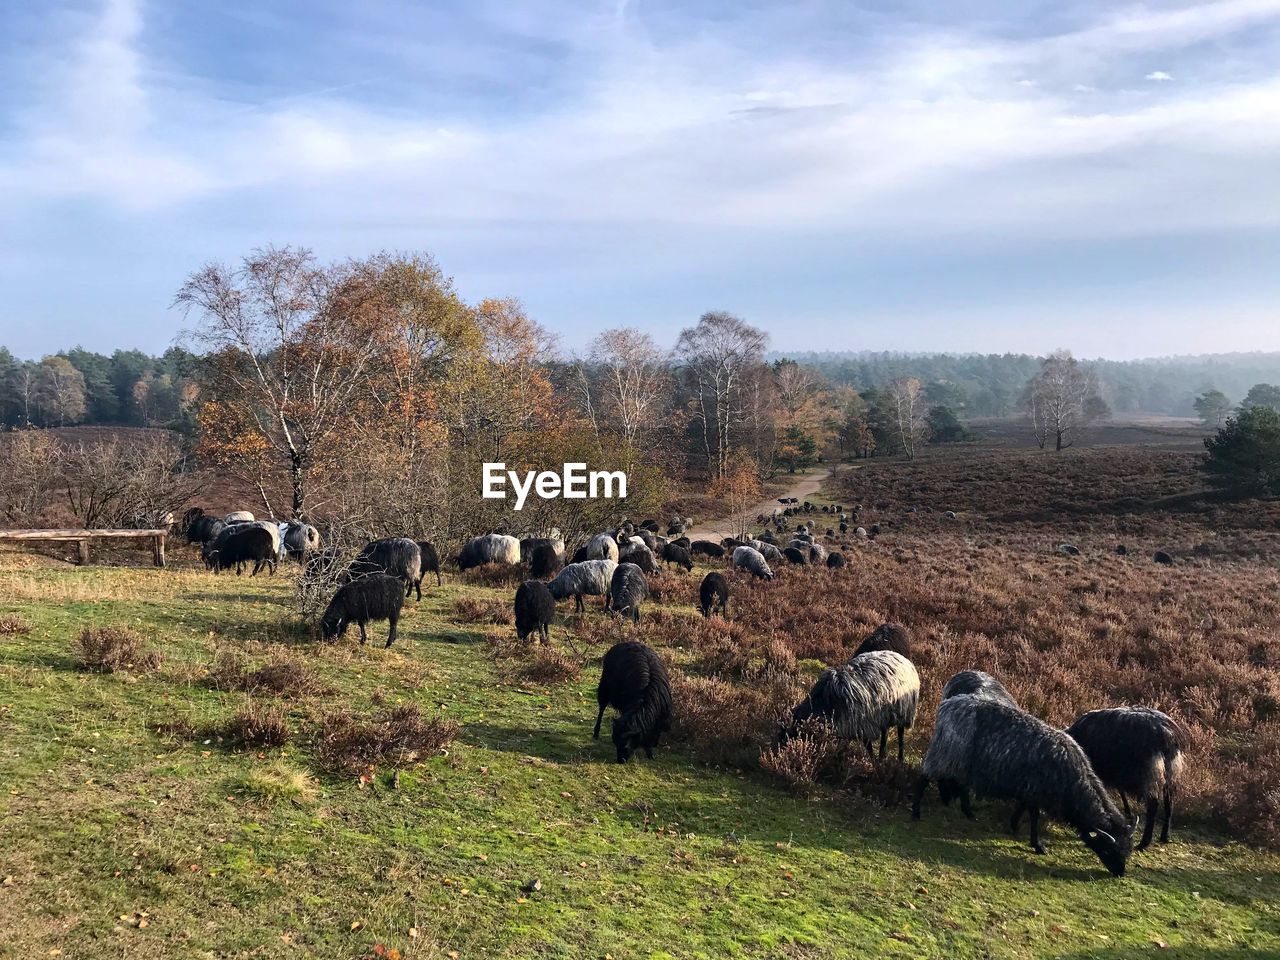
[184, 502, 1185, 876]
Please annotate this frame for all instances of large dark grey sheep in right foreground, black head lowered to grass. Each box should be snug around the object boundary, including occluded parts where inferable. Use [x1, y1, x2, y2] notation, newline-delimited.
[911, 694, 1133, 877]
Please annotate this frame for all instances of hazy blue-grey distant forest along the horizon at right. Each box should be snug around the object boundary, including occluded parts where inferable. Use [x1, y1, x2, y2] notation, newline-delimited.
[787, 352, 1280, 417]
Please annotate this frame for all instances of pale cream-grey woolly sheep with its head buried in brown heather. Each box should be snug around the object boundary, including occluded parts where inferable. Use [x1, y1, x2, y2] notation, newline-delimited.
[778, 650, 920, 763]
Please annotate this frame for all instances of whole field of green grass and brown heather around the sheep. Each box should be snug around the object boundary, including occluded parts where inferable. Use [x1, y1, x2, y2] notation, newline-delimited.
[0, 444, 1280, 960]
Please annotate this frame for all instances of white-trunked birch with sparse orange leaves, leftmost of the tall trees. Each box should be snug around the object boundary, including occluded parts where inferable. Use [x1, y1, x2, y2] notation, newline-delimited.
[177, 247, 381, 520]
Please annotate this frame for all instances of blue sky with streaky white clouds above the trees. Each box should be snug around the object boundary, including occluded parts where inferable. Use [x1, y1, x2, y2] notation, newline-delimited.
[0, 0, 1280, 358]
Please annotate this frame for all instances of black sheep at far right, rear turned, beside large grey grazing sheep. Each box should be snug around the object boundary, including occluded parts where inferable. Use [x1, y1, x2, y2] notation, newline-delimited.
[1066, 707, 1187, 850]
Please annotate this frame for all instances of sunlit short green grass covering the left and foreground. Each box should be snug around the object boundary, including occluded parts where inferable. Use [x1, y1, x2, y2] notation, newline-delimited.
[0, 568, 1280, 960]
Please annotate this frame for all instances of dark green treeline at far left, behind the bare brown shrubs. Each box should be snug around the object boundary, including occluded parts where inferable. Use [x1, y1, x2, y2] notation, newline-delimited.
[0, 347, 198, 433]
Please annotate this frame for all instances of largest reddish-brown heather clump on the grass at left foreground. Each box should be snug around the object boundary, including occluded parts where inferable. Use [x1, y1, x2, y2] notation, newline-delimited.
[316, 704, 460, 777]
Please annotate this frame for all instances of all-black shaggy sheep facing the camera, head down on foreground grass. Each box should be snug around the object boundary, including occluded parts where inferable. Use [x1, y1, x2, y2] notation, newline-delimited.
[591, 641, 671, 763]
